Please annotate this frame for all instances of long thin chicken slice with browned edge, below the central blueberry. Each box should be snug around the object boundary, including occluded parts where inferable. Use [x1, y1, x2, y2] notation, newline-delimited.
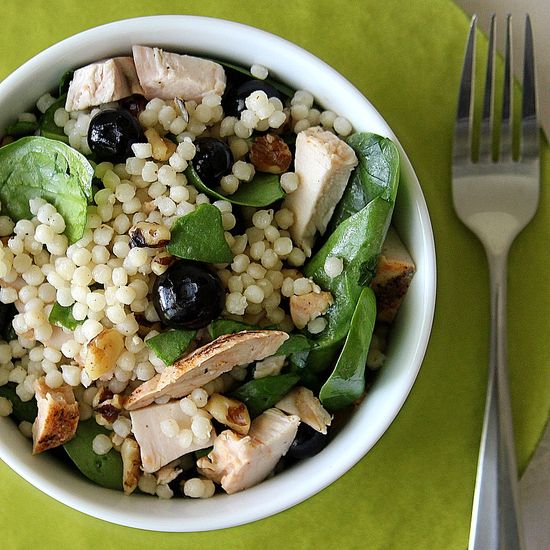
[125, 330, 288, 410]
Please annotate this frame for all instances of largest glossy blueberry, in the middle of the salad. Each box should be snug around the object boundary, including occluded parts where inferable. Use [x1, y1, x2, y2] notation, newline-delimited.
[153, 260, 225, 329]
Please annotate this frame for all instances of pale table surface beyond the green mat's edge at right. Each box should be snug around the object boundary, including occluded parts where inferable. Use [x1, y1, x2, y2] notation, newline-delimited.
[456, 0, 550, 550]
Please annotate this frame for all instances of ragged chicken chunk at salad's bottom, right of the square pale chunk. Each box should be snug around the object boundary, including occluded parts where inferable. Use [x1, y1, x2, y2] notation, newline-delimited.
[197, 409, 300, 494]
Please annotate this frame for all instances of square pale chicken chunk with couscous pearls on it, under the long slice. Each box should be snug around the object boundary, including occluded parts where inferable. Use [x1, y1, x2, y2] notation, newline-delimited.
[130, 401, 216, 473]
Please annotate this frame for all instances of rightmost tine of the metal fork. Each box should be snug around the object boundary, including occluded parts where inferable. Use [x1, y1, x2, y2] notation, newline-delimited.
[520, 15, 539, 160]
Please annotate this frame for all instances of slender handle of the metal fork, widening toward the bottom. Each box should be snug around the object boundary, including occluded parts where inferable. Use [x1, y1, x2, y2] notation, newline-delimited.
[468, 252, 523, 550]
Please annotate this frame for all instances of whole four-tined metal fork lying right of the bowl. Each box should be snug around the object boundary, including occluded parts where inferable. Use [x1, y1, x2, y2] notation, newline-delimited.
[452, 12, 540, 550]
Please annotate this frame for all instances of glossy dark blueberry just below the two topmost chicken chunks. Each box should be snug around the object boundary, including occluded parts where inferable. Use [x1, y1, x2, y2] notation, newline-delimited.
[88, 109, 145, 162]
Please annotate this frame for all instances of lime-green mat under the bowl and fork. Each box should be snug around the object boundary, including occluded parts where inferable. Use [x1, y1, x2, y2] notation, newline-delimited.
[0, 0, 550, 550]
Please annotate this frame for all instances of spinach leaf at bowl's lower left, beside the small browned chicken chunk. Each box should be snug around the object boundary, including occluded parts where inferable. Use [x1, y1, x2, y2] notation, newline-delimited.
[63, 418, 122, 490]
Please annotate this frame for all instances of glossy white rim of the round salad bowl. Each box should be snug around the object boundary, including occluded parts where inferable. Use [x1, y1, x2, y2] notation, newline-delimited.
[0, 15, 436, 532]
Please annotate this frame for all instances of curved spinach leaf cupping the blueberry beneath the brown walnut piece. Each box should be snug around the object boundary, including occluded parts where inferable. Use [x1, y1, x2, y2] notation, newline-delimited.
[185, 164, 285, 208]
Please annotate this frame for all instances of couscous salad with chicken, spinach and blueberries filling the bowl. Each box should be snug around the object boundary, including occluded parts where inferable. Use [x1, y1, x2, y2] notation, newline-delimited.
[0, 16, 436, 532]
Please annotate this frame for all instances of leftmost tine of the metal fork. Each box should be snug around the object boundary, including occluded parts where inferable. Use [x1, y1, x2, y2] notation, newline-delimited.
[453, 15, 477, 160]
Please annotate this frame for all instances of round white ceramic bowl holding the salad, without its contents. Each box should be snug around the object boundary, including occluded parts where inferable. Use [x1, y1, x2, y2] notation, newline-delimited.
[0, 16, 435, 531]
